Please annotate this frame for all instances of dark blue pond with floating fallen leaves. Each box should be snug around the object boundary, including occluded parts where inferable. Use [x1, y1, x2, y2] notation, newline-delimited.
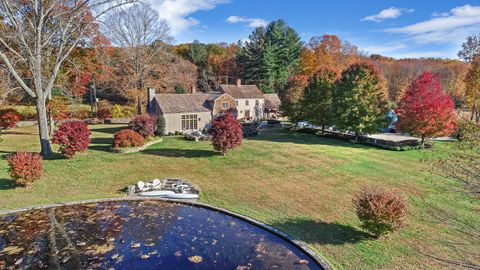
[0, 201, 321, 269]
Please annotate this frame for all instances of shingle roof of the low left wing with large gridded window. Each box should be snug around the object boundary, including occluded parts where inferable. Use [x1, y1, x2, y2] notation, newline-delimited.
[155, 93, 212, 113]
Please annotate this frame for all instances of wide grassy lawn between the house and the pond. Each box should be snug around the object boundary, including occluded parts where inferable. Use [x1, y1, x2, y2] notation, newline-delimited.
[0, 125, 480, 269]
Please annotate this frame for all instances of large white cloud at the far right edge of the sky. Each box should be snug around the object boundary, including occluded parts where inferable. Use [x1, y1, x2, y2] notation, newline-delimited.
[385, 5, 480, 44]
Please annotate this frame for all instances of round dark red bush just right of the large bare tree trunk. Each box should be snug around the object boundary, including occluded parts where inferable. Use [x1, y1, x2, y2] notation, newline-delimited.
[52, 120, 90, 158]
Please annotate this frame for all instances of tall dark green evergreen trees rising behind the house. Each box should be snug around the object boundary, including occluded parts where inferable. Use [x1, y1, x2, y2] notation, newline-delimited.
[239, 20, 302, 93]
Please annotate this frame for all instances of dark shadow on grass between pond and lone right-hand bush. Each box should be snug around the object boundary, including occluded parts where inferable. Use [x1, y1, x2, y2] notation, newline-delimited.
[272, 218, 375, 245]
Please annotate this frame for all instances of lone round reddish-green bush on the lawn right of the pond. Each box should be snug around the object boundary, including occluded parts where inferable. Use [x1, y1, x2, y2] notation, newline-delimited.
[353, 188, 406, 237]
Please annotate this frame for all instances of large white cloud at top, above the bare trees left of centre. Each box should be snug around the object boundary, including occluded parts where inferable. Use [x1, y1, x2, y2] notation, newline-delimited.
[149, 0, 229, 35]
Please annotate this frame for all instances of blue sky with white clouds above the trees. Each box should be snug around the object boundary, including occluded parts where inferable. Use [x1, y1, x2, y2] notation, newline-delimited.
[150, 0, 480, 58]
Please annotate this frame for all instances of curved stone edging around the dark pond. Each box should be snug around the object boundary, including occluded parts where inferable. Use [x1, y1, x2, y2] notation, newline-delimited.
[0, 196, 333, 270]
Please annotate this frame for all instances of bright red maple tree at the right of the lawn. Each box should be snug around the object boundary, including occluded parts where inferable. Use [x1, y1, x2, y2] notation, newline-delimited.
[396, 72, 457, 144]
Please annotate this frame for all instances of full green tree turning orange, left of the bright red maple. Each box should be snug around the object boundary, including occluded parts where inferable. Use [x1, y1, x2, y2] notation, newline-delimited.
[333, 63, 387, 139]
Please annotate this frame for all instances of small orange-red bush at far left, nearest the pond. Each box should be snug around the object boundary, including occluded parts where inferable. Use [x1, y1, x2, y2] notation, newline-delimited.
[8, 152, 43, 187]
